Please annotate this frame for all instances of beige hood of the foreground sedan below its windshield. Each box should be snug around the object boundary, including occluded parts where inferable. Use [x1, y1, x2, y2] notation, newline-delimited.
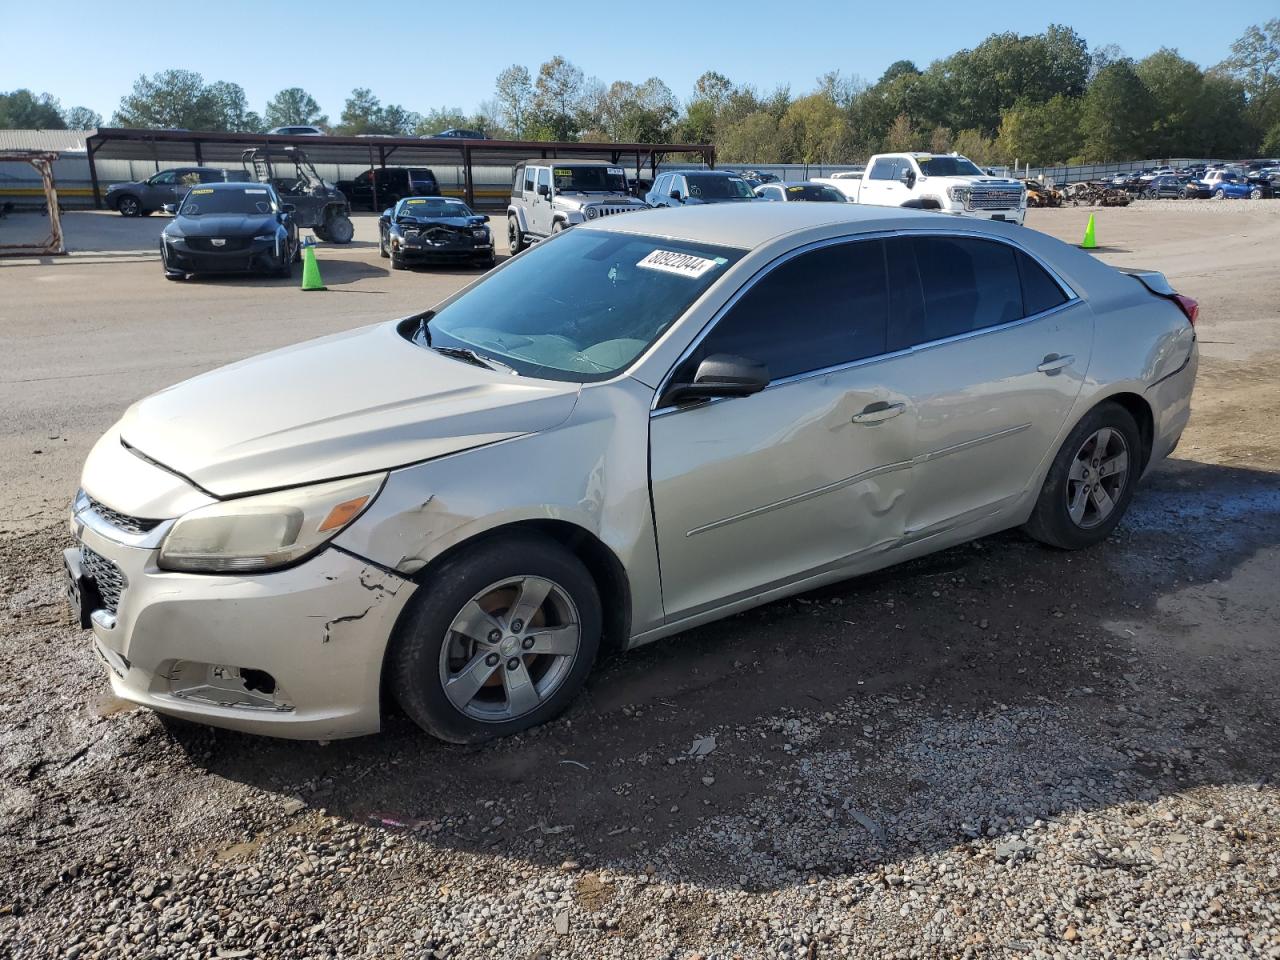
[119, 324, 579, 497]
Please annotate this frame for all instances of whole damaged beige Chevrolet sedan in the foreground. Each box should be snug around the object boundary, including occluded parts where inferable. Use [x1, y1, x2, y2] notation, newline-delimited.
[65, 204, 1197, 742]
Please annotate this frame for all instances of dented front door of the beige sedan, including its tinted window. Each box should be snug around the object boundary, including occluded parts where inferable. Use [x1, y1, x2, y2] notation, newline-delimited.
[649, 239, 915, 621]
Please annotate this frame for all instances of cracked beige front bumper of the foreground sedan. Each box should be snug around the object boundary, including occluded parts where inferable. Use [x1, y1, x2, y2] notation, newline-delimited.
[67, 513, 415, 740]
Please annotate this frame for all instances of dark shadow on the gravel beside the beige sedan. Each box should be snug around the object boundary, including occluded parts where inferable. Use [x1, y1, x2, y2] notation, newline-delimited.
[169, 461, 1280, 890]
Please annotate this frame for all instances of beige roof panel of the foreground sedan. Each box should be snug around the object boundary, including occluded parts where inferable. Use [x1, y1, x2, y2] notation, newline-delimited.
[588, 204, 957, 250]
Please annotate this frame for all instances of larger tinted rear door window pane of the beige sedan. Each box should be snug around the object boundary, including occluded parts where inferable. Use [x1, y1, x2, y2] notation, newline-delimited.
[911, 237, 1024, 343]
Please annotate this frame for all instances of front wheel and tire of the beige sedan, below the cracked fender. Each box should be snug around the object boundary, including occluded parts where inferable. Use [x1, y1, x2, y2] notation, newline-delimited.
[388, 534, 602, 744]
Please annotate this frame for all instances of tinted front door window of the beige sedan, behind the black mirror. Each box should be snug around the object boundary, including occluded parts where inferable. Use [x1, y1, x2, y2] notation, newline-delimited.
[677, 241, 888, 380]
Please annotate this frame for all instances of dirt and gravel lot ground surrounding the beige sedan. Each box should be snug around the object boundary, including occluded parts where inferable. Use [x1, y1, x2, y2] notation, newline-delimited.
[0, 202, 1280, 960]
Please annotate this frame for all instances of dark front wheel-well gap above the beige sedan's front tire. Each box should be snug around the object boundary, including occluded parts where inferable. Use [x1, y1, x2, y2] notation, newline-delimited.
[410, 518, 631, 653]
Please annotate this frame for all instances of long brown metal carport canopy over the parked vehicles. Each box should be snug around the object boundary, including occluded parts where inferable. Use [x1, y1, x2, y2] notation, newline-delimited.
[84, 127, 716, 207]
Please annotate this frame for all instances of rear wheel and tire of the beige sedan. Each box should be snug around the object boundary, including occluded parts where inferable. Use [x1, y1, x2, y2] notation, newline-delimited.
[1024, 402, 1143, 550]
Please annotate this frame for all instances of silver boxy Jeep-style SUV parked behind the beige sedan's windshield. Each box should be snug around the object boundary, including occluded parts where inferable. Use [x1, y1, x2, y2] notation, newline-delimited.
[507, 160, 649, 253]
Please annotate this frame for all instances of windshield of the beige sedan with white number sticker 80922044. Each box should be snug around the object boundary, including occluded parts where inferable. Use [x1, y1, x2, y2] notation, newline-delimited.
[410, 227, 742, 383]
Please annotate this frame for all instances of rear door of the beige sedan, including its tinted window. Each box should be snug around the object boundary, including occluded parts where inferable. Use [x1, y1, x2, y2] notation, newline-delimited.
[887, 227, 1093, 540]
